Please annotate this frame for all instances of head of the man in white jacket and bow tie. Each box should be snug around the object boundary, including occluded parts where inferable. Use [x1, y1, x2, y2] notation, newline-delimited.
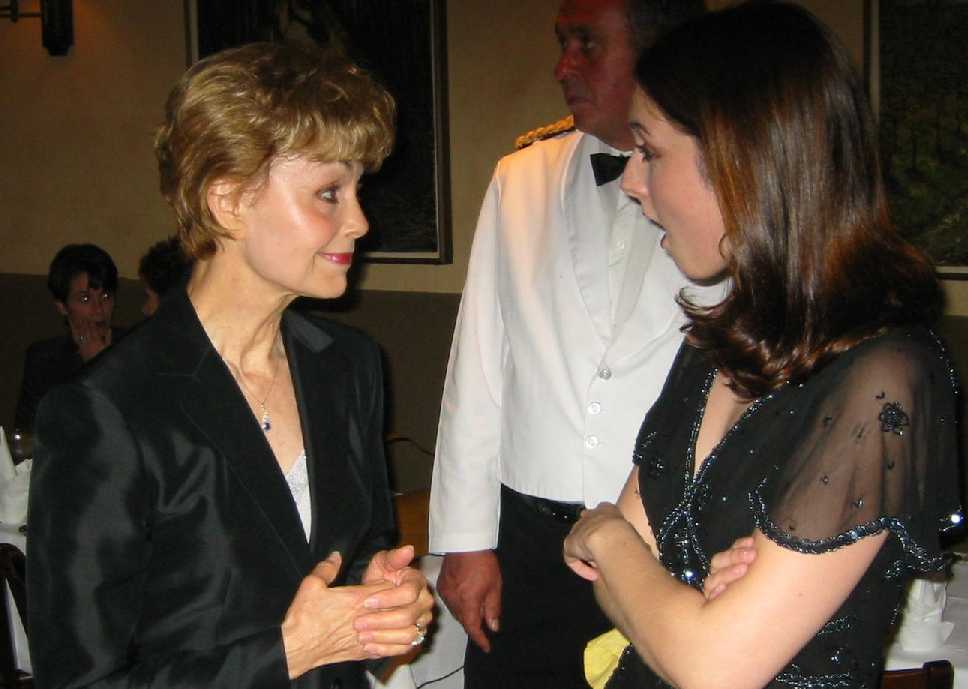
[555, 0, 704, 151]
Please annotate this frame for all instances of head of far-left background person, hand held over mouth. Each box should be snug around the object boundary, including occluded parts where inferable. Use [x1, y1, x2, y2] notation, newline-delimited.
[47, 244, 118, 360]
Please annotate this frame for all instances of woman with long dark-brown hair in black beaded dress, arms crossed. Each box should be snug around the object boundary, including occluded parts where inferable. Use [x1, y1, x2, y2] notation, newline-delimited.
[564, 3, 960, 689]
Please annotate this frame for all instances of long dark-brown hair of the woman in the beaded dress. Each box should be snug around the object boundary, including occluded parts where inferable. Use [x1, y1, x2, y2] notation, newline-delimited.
[636, 3, 941, 398]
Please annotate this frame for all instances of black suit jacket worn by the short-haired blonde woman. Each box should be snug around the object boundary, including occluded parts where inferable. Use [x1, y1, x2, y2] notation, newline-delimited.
[27, 293, 393, 689]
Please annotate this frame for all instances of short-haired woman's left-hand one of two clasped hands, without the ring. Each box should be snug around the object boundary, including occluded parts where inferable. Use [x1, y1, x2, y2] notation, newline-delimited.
[282, 553, 393, 679]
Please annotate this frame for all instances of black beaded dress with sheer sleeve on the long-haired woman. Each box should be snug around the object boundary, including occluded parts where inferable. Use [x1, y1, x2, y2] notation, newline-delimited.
[607, 328, 961, 689]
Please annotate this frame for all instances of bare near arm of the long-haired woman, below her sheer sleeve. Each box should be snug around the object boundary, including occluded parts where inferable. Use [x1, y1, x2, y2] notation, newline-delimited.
[588, 520, 887, 689]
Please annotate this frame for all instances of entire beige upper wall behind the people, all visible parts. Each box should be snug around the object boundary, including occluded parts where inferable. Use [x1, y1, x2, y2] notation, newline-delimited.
[0, 0, 968, 314]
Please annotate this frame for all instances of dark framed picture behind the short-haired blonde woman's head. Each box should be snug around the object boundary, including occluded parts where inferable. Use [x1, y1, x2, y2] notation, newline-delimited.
[185, 0, 451, 263]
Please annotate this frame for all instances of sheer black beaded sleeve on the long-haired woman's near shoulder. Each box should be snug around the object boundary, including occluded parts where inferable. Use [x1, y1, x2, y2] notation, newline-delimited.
[751, 335, 960, 571]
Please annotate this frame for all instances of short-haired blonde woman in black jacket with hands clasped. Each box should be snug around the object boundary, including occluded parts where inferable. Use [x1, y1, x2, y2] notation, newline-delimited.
[27, 44, 432, 689]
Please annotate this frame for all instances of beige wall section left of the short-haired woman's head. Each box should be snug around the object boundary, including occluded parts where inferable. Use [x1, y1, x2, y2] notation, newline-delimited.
[0, 0, 185, 276]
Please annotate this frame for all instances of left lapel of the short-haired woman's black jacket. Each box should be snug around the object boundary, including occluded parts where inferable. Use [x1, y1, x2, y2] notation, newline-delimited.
[154, 296, 312, 577]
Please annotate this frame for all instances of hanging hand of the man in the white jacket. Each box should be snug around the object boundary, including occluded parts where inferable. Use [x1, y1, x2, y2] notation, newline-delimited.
[437, 550, 501, 653]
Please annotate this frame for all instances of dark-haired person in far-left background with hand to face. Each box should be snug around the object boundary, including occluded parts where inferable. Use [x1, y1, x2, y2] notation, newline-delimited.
[14, 244, 120, 433]
